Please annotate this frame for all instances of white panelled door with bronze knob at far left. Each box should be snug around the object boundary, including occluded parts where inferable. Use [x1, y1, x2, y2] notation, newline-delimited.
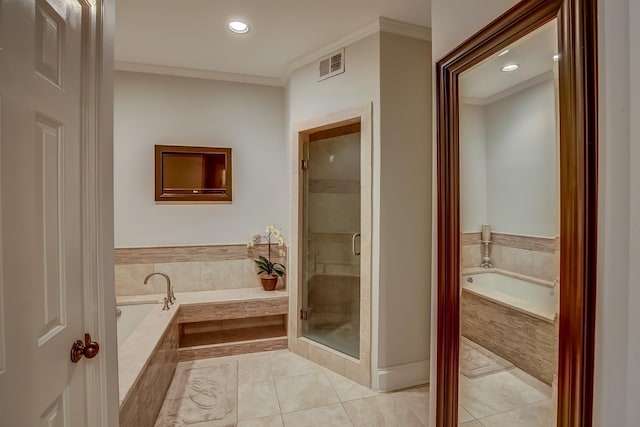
[0, 0, 112, 427]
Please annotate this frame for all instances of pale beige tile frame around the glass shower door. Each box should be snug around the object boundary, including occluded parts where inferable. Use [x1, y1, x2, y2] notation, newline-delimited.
[288, 103, 373, 387]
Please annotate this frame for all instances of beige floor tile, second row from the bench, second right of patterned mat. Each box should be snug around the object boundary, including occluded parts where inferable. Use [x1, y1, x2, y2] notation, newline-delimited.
[276, 373, 340, 413]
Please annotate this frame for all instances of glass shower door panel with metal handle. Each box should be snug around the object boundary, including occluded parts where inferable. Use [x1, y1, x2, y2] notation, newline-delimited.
[302, 126, 360, 358]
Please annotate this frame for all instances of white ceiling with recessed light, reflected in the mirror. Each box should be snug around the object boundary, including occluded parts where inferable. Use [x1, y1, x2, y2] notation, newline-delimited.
[460, 20, 558, 104]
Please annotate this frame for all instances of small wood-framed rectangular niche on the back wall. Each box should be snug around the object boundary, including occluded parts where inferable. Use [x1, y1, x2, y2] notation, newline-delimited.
[155, 145, 232, 203]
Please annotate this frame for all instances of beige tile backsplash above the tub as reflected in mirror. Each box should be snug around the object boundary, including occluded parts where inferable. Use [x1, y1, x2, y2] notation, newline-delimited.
[462, 232, 560, 282]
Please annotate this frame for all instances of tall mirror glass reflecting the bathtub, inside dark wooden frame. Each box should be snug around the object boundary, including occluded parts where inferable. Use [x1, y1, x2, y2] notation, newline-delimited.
[459, 20, 560, 426]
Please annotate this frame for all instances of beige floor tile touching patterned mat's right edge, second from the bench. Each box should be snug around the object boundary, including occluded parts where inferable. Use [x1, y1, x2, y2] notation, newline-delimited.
[238, 381, 280, 421]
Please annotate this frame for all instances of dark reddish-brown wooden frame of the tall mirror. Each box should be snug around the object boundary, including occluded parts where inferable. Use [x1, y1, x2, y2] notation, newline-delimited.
[434, 0, 598, 427]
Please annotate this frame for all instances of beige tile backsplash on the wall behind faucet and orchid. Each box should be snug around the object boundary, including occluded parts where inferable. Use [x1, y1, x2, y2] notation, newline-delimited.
[115, 245, 287, 296]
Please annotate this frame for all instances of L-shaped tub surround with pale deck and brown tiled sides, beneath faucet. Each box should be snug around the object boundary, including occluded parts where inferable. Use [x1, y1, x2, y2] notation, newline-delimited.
[117, 288, 288, 427]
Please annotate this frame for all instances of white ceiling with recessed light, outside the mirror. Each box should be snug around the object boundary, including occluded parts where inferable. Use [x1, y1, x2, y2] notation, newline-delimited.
[115, 0, 431, 83]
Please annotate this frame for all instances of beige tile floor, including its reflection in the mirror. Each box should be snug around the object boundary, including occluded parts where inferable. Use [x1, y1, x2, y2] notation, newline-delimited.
[156, 350, 553, 427]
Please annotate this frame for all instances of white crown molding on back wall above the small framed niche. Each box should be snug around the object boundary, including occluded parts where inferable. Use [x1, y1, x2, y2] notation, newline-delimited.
[114, 61, 284, 86]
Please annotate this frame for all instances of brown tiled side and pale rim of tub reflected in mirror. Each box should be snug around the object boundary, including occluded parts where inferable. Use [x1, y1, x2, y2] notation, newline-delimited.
[460, 275, 558, 384]
